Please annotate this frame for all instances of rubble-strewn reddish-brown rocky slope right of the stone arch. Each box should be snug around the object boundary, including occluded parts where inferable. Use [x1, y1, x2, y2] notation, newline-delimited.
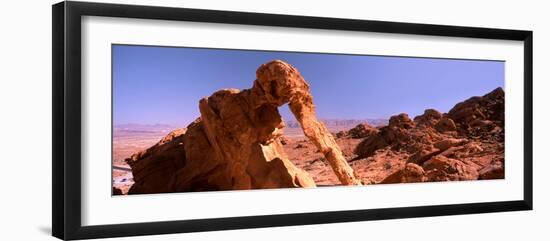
[355, 88, 504, 183]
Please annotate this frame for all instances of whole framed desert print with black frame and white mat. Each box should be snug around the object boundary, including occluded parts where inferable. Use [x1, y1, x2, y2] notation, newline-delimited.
[52, 1, 533, 239]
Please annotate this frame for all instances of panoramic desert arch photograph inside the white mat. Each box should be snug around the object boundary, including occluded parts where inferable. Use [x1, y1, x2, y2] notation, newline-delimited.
[111, 44, 505, 195]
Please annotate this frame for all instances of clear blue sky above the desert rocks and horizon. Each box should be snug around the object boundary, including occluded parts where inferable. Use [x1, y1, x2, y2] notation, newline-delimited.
[112, 45, 504, 126]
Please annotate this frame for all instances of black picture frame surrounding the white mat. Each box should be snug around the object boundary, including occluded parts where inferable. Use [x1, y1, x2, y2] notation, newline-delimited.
[52, 1, 533, 240]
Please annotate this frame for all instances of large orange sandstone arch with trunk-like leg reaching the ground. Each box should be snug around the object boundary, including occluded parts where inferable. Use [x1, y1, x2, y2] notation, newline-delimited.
[126, 61, 361, 194]
